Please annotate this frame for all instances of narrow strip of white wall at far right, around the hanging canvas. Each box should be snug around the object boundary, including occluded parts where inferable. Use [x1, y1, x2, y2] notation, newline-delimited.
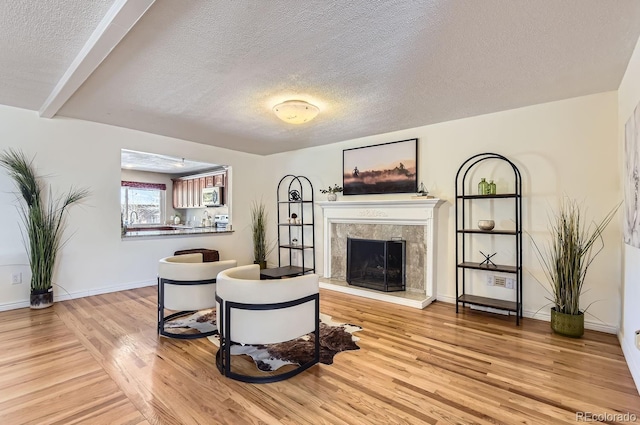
[618, 32, 640, 391]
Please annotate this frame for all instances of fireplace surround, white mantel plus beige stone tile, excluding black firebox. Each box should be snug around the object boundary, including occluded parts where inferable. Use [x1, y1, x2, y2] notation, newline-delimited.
[317, 199, 443, 308]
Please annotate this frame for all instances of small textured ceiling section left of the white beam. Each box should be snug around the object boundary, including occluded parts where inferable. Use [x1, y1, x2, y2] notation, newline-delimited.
[0, 0, 113, 110]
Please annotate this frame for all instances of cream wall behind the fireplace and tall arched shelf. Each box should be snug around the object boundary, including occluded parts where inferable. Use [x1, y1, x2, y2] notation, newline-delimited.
[268, 92, 622, 332]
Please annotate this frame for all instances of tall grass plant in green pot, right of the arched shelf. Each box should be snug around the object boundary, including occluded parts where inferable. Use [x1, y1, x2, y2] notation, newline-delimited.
[533, 198, 620, 338]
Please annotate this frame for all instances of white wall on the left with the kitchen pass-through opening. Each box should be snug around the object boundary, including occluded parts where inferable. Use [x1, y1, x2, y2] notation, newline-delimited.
[0, 106, 264, 309]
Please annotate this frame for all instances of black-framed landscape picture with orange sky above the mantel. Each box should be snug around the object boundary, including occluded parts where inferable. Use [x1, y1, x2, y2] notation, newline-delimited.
[342, 139, 418, 195]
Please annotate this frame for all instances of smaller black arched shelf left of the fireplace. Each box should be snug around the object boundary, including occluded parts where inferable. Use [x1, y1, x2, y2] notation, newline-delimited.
[277, 174, 316, 276]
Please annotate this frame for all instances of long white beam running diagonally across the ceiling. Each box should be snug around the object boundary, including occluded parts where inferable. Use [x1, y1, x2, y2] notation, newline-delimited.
[40, 0, 155, 118]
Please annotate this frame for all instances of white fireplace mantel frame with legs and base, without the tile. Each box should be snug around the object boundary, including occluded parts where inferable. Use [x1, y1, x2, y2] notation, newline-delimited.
[316, 198, 444, 308]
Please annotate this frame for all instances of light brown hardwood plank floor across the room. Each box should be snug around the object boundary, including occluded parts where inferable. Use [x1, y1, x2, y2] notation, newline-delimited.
[0, 287, 640, 425]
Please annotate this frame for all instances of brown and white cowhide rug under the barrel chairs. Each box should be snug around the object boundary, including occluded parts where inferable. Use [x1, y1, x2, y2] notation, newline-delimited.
[165, 310, 362, 372]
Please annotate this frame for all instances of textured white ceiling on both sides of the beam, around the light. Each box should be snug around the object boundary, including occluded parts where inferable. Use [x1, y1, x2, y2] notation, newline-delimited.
[0, 0, 640, 154]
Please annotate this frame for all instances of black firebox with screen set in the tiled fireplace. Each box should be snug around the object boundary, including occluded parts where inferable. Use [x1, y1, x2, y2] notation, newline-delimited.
[347, 238, 406, 292]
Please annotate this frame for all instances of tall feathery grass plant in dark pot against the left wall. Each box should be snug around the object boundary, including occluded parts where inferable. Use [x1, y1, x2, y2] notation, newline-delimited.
[0, 149, 89, 308]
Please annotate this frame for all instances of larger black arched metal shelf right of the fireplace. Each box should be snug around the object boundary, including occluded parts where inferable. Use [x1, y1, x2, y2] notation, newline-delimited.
[455, 153, 522, 325]
